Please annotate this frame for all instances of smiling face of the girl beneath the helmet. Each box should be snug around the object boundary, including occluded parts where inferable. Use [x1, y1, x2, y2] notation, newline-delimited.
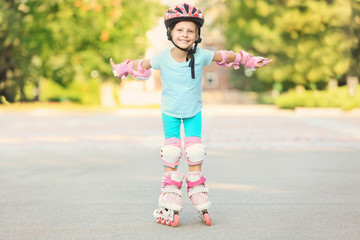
[171, 21, 198, 49]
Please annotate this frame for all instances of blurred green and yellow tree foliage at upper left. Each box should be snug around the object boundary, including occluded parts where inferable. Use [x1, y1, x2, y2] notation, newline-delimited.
[0, 0, 164, 103]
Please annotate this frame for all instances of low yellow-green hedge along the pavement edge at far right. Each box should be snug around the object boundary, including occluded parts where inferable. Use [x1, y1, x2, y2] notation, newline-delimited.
[275, 86, 360, 110]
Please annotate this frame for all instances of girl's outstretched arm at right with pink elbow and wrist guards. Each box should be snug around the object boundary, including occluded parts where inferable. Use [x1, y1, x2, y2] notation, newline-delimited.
[213, 50, 272, 69]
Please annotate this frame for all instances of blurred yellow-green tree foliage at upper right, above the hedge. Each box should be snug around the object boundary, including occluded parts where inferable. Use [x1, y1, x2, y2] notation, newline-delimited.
[221, 0, 360, 86]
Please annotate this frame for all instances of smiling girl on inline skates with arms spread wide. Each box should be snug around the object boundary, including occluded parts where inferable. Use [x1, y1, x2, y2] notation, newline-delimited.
[110, 3, 272, 227]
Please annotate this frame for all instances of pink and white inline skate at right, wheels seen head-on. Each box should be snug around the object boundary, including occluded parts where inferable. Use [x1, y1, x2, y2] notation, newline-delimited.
[186, 172, 211, 226]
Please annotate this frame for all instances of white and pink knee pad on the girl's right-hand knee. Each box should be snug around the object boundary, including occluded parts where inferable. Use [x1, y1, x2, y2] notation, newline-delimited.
[185, 137, 206, 165]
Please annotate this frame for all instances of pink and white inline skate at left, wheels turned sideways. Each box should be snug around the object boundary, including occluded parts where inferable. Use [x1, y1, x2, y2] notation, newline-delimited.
[153, 171, 185, 227]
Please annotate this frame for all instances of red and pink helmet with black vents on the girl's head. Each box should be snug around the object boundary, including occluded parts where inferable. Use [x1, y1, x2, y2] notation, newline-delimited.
[164, 3, 204, 28]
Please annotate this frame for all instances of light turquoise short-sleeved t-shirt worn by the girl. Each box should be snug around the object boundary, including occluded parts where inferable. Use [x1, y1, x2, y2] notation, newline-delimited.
[150, 48, 214, 118]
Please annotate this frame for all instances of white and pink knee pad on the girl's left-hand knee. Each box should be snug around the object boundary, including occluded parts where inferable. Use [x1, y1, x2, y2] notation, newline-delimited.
[160, 138, 182, 168]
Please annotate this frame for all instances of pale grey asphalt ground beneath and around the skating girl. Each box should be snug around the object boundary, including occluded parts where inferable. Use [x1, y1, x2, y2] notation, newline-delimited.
[0, 105, 360, 240]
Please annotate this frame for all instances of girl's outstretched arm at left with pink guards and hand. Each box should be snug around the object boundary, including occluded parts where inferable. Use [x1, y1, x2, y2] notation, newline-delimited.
[110, 58, 151, 80]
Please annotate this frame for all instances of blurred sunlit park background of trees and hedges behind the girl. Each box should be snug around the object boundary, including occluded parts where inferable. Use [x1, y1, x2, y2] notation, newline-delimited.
[0, 0, 360, 110]
